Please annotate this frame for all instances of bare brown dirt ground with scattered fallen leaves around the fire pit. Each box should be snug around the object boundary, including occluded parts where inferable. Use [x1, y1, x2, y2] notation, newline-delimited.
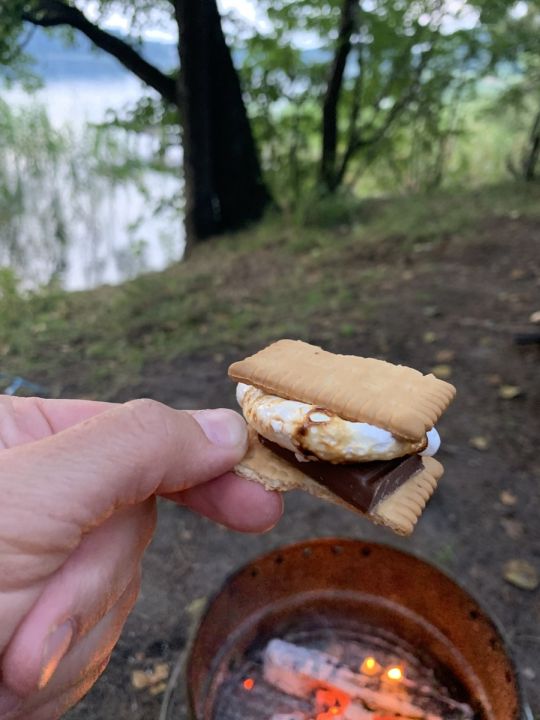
[66, 218, 540, 720]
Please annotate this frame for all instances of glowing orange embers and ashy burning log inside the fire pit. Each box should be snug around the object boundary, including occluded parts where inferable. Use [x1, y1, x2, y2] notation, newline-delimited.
[243, 639, 474, 720]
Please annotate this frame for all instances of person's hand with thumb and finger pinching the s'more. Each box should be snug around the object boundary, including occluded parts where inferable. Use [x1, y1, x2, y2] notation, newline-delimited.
[0, 397, 282, 720]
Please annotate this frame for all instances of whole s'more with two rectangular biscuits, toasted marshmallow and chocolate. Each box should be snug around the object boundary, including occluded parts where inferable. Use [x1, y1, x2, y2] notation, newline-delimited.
[229, 340, 455, 535]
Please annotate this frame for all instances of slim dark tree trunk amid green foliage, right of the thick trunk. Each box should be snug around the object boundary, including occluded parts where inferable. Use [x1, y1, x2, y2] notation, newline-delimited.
[320, 0, 358, 192]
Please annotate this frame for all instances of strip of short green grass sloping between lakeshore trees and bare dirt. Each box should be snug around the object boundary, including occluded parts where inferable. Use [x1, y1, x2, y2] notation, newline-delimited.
[0, 184, 540, 397]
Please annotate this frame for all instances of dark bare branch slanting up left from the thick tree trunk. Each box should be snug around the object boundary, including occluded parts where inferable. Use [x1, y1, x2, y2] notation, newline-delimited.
[23, 0, 179, 106]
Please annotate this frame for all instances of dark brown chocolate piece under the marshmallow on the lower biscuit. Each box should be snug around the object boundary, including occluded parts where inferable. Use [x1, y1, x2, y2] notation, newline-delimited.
[259, 435, 424, 513]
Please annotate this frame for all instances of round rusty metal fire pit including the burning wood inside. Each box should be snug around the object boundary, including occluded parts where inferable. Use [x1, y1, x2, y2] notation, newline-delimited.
[187, 539, 530, 720]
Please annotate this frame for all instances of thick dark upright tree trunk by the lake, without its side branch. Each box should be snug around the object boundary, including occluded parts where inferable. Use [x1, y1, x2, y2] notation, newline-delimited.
[174, 0, 270, 244]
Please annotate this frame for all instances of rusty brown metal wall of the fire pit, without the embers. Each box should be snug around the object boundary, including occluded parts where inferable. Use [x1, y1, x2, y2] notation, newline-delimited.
[186, 538, 532, 720]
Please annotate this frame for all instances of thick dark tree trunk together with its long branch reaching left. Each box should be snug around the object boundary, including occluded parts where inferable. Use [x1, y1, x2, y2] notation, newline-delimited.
[23, 0, 271, 245]
